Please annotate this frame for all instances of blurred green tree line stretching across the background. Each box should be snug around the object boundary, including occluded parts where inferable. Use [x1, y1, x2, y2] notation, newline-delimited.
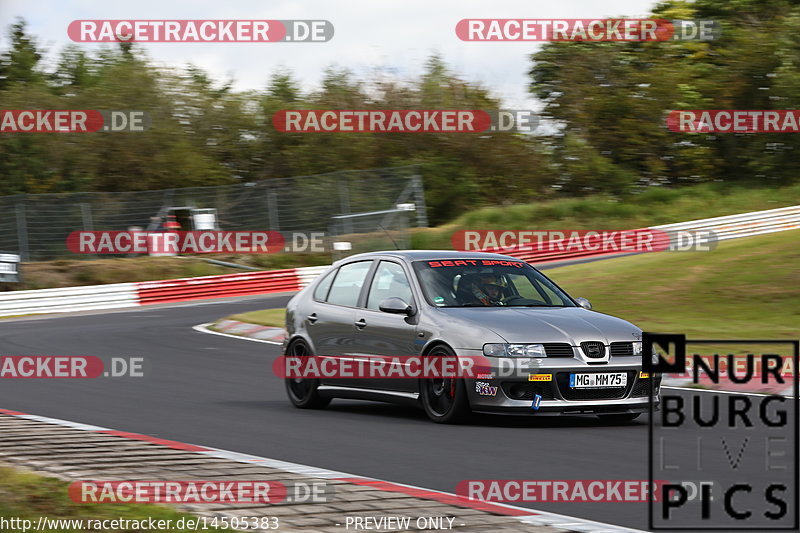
[0, 0, 800, 223]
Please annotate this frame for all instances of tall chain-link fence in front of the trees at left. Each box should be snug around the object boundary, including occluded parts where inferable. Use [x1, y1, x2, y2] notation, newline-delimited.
[0, 165, 427, 261]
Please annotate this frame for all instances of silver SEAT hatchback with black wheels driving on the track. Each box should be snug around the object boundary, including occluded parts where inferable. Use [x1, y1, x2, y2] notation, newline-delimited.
[284, 250, 660, 423]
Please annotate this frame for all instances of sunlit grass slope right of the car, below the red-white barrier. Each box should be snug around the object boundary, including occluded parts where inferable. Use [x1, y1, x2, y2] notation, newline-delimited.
[545, 230, 800, 339]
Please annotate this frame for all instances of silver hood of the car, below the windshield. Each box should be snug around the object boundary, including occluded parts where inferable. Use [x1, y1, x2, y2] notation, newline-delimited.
[440, 307, 642, 346]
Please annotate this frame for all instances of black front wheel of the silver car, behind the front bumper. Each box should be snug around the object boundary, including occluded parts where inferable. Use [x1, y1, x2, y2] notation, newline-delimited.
[419, 346, 470, 424]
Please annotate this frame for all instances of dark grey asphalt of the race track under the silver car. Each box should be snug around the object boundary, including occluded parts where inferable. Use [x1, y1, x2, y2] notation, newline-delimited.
[0, 294, 793, 529]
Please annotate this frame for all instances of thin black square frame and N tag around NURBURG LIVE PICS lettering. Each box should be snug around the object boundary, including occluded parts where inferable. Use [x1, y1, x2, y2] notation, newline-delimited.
[642, 332, 800, 531]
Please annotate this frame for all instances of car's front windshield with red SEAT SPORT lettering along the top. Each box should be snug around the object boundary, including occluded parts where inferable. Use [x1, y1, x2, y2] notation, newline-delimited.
[414, 259, 576, 307]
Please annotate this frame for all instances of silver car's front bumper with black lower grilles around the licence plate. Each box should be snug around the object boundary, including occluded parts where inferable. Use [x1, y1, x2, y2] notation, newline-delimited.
[465, 358, 661, 415]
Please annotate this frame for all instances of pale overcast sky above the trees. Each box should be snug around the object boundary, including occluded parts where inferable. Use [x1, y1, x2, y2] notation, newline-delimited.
[0, 0, 656, 109]
